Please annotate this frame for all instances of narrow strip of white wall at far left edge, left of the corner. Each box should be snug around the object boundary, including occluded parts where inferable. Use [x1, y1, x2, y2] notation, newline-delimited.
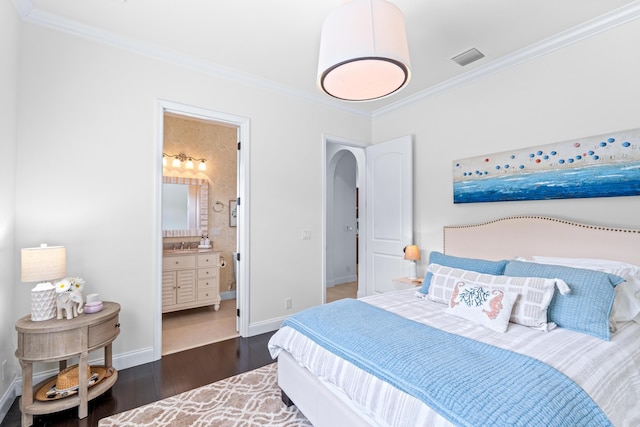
[0, 1, 19, 420]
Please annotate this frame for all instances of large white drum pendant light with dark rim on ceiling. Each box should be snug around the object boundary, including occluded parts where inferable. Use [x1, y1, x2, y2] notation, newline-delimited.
[318, 0, 411, 101]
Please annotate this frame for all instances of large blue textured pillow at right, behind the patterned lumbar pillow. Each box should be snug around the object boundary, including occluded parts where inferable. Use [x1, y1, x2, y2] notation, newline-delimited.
[504, 261, 624, 341]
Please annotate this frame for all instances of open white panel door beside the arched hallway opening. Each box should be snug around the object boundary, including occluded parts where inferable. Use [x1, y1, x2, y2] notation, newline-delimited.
[365, 136, 413, 295]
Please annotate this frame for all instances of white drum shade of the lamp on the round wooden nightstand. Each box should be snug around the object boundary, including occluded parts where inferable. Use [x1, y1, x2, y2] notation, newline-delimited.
[21, 245, 67, 282]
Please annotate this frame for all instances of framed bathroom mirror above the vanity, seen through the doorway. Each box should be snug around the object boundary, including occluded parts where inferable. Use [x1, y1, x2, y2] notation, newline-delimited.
[162, 176, 209, 237]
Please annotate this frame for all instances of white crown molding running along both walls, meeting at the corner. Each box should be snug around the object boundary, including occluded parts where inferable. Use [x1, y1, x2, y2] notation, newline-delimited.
[13, 0, 640, 118]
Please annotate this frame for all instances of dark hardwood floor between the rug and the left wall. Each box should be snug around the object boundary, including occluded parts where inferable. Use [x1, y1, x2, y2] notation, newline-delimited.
[0, 331, 275, 427]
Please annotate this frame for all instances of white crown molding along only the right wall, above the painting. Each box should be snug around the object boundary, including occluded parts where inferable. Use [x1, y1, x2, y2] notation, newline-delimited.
[372, 0, 640, 118]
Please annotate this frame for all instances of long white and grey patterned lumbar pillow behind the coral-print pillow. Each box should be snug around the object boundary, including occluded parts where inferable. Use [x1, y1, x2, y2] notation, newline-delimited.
[427, 264, 569, 331]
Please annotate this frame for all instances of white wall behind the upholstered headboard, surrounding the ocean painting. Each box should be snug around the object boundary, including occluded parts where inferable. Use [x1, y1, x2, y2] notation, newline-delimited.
[373, 20, 640, 272]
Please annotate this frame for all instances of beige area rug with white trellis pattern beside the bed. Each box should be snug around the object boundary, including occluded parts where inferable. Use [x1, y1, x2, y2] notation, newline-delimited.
[98, 363, 311, 427]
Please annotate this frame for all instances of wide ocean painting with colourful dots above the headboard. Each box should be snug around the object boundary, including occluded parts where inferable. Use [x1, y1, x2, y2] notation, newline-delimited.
[453, 129, 640, 203]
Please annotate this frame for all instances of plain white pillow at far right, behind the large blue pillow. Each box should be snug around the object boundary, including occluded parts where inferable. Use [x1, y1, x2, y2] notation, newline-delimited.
[532, 256, 640, 322]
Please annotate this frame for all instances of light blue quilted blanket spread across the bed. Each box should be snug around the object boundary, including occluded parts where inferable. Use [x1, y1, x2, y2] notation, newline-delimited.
[283, 299, 611, 426]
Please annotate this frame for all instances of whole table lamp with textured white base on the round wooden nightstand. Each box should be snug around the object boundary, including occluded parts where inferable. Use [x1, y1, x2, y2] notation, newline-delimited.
[21, 243, 67, 322]
